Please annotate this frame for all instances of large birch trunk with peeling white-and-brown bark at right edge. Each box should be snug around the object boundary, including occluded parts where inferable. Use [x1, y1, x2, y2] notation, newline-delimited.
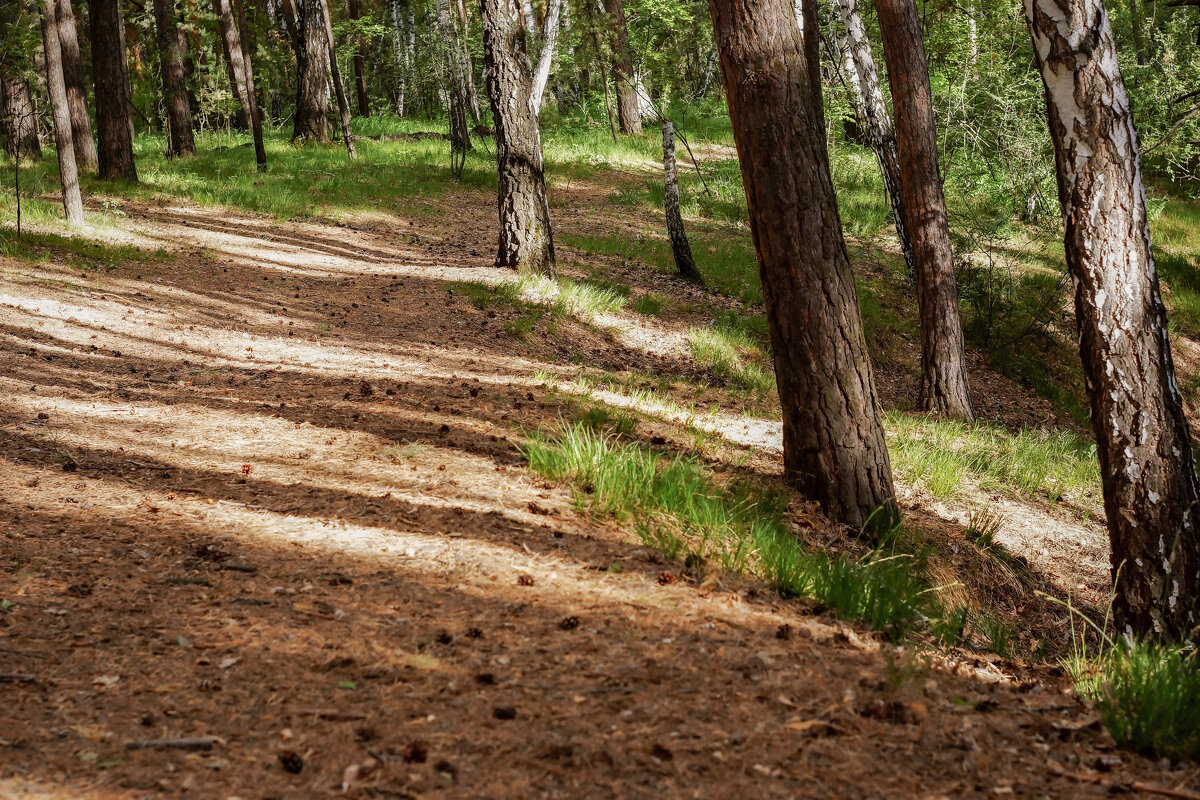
[1025, 0, 1200, 640]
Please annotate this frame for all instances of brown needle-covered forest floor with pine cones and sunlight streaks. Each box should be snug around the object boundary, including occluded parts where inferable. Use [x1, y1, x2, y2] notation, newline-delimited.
[0, 130, 1200, 800]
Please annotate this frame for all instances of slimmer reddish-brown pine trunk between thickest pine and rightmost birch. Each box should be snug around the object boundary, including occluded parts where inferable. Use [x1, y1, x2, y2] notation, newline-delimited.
[875, 0, 973, 420]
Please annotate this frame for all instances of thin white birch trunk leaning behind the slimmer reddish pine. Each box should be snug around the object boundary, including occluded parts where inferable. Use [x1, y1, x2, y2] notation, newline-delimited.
[836, 0, 917, 277]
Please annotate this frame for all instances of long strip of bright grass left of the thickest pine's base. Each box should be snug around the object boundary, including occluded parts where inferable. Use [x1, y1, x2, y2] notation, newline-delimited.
[522, 422, 961, 640]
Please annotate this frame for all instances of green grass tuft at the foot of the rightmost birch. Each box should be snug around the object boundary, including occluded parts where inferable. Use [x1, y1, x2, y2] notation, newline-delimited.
[1075, 642, 1200, 760]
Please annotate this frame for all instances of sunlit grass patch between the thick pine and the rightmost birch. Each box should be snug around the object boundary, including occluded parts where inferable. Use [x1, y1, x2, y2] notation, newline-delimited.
[887, 411, 1100, 503]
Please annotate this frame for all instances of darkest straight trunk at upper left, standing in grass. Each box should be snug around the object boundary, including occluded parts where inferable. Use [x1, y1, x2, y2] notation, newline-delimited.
[89, 0, 138, 181]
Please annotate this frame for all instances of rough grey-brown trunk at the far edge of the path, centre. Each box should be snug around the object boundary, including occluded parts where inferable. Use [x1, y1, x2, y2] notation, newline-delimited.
[480, 0, 554, 275]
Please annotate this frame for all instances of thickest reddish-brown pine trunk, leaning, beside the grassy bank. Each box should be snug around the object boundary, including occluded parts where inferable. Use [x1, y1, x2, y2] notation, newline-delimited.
[709, 0, 894, 525]
